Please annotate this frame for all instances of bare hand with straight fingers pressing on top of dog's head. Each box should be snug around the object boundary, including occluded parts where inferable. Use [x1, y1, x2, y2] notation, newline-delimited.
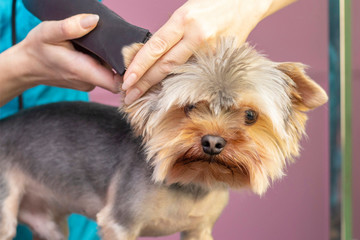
[122, 0, 294, 104]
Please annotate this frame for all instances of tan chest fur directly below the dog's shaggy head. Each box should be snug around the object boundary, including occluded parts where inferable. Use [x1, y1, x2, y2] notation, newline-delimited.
[141, 189, 229, 239]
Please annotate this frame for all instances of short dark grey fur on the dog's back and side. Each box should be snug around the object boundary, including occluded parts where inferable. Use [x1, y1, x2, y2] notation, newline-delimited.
[0, 102, 151, 212]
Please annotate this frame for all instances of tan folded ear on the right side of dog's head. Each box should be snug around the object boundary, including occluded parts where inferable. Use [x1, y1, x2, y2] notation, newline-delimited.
[277, 62, 328, 109]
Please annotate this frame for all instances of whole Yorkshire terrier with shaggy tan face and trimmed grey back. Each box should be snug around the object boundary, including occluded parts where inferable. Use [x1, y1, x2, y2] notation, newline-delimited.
[0, 39, 327, 240]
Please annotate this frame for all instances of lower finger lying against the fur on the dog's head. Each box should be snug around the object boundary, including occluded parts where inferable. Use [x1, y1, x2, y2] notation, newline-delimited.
[124, 40, 193, 105]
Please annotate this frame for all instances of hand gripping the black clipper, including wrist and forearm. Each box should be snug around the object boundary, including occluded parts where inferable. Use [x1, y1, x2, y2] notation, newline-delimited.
[0, 14, 122, 106]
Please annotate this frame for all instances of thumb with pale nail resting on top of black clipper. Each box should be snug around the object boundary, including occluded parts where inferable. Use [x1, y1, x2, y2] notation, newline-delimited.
[41, 14, 99, 43]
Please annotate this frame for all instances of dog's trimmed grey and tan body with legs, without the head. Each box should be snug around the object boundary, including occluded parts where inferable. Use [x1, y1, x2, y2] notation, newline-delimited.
[0, 102, 228, 239]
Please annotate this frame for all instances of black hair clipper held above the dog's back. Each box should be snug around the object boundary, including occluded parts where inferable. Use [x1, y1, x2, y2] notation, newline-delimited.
[23, 0, 151, 75]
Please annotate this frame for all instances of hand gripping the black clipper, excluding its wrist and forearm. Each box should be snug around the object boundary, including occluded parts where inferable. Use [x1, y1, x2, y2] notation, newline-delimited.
[22, 14, 119, 92]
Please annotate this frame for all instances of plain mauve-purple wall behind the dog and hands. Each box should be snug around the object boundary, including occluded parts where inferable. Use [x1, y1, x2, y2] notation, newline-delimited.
[91, 0, 360, 240]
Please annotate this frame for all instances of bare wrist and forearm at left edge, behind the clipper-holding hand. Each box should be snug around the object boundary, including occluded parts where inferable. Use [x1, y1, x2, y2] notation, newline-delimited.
[0, 42, 34, 106]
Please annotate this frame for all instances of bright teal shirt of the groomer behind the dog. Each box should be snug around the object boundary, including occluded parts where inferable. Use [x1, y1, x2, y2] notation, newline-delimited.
[0, 0, 99, 240]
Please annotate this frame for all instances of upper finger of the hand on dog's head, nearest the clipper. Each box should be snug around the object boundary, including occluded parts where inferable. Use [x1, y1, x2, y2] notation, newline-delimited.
[122, 14, 184, 90]
